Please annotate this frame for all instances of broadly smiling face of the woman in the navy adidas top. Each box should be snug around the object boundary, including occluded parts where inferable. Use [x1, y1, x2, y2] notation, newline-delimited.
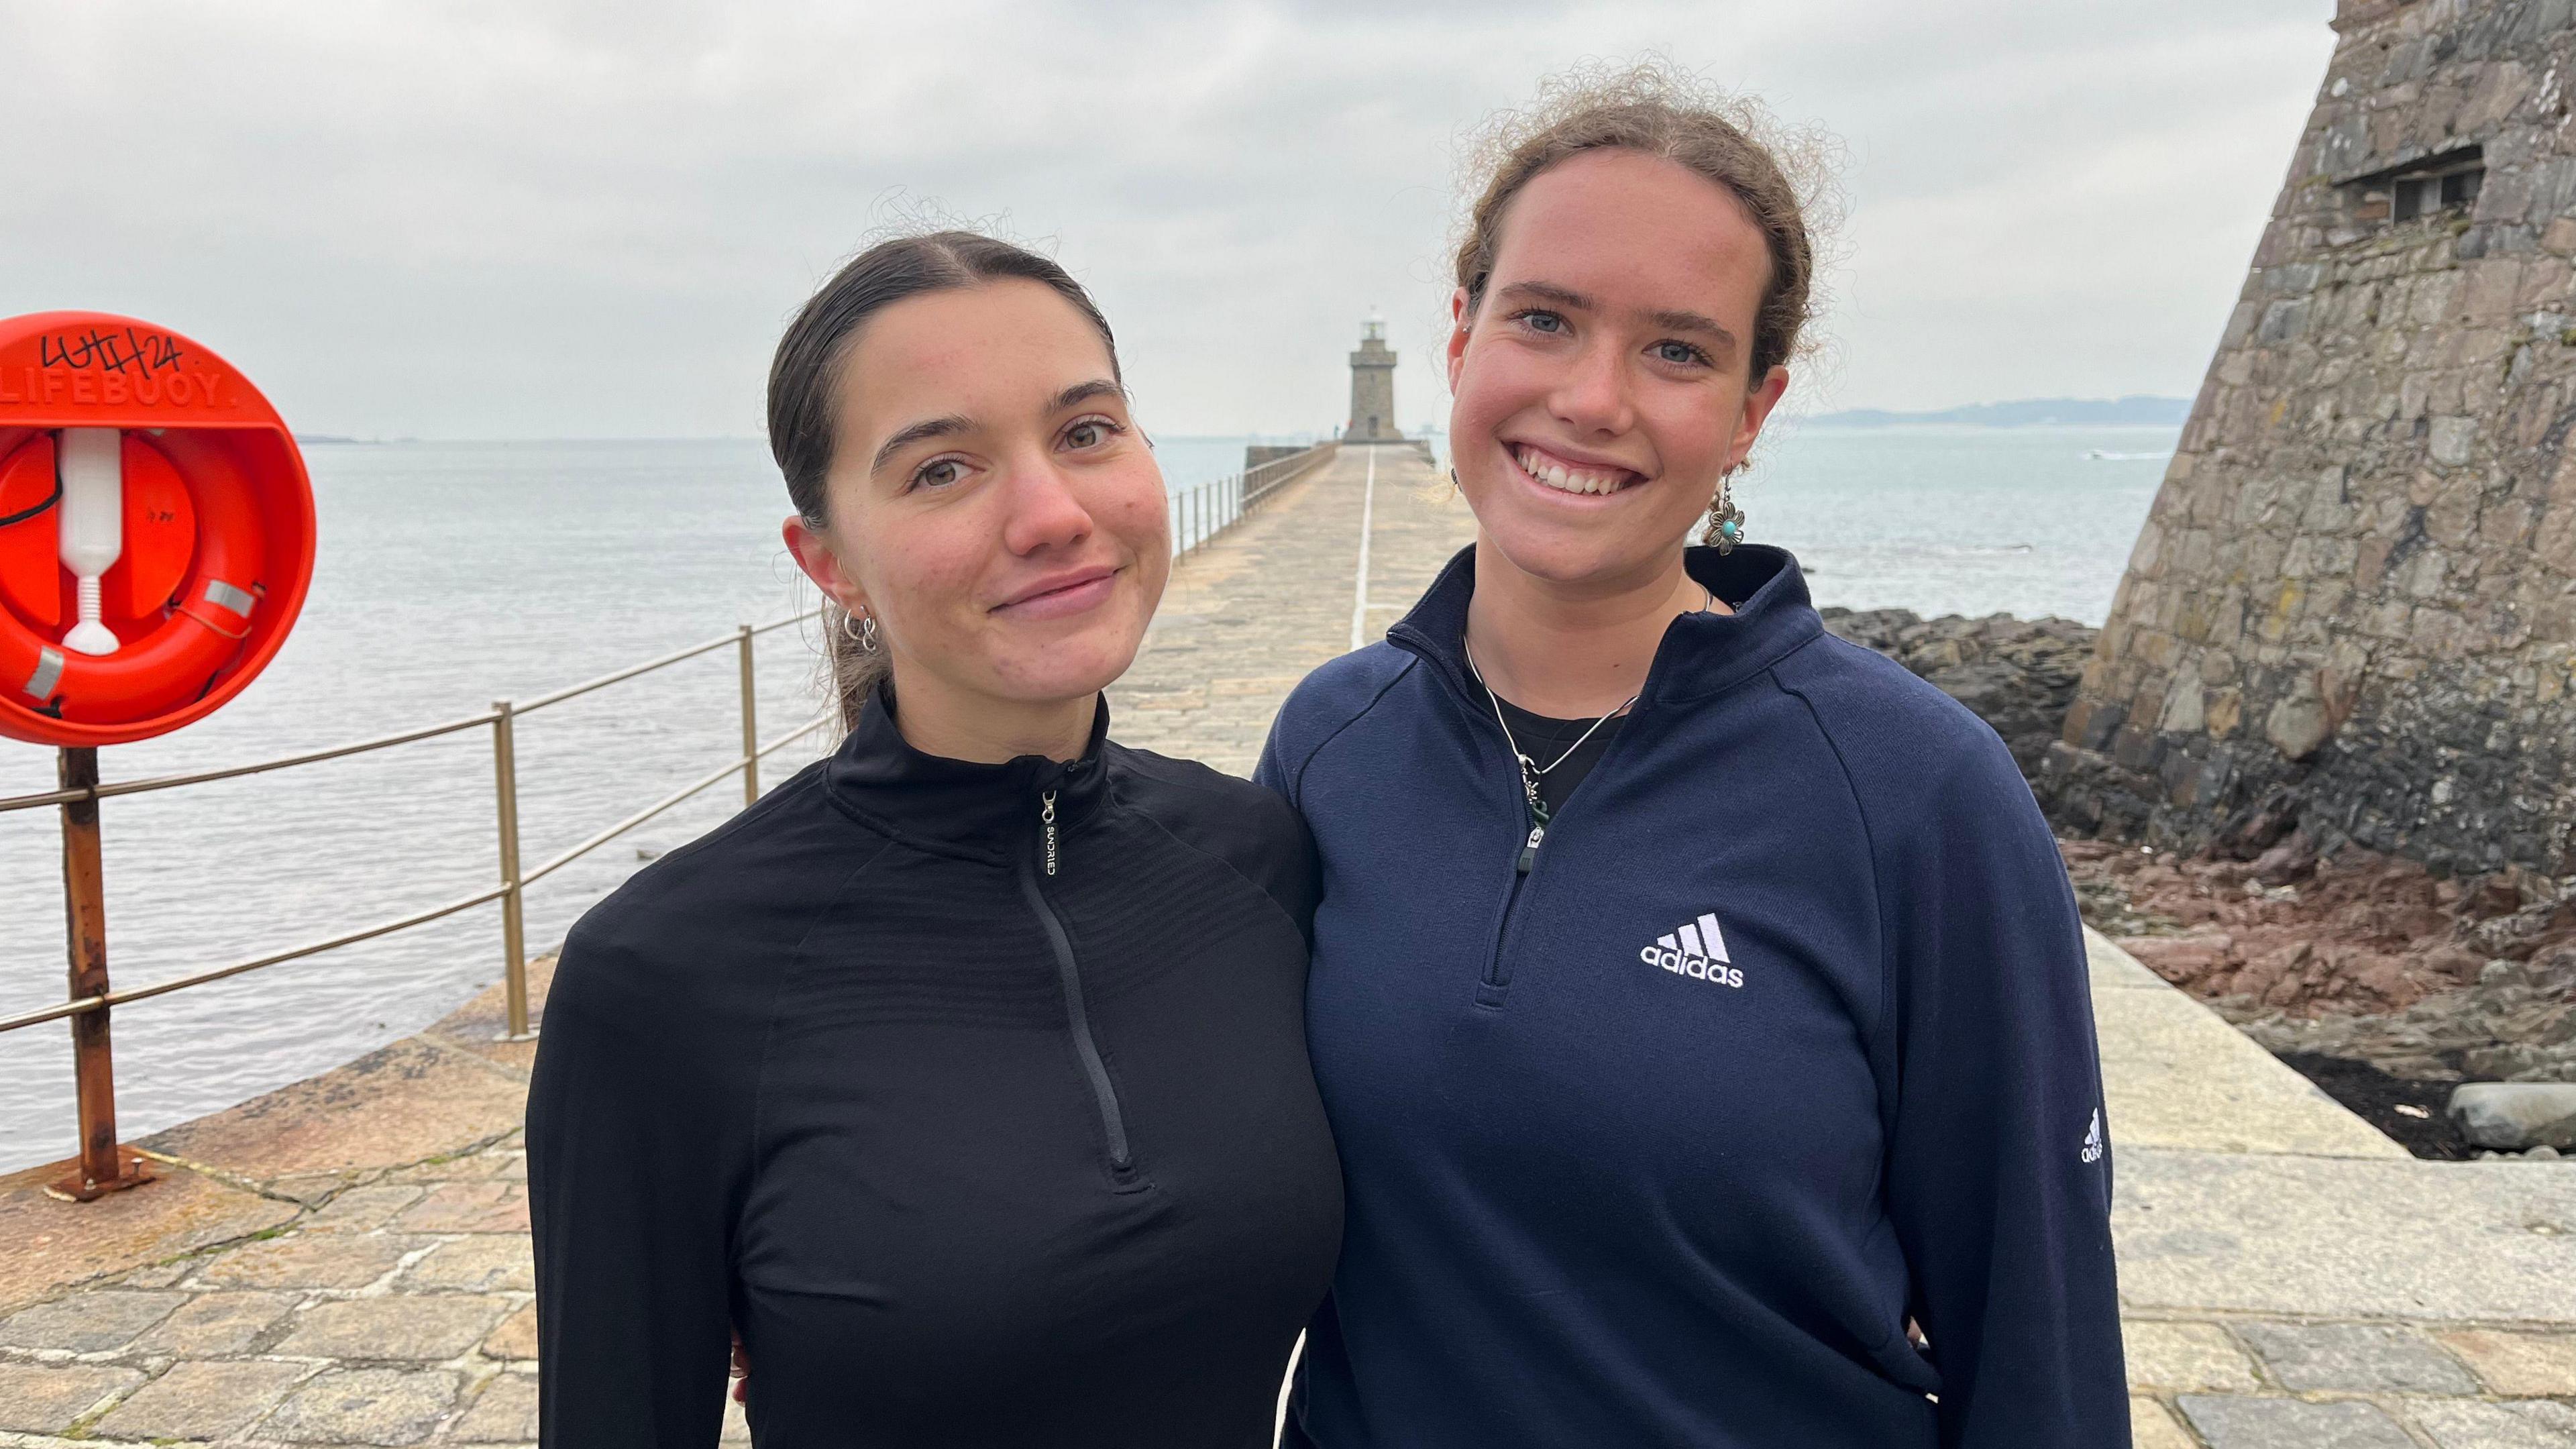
[1448, 147, 1788, 588]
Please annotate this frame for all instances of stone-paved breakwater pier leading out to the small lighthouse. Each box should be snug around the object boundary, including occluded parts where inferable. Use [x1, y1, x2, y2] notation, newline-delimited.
[0, 446, 2576, 1449]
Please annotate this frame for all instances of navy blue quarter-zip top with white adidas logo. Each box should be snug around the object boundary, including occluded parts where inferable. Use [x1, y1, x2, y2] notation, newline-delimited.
[1260, 547, 2128, 1449]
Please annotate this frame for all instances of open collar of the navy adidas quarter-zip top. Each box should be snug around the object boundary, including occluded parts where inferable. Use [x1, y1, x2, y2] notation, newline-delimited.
[1386, 544, 1824, 712]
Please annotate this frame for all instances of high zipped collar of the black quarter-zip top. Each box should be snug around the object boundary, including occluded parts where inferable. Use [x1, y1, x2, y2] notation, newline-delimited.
[824, 681, 1110, 861]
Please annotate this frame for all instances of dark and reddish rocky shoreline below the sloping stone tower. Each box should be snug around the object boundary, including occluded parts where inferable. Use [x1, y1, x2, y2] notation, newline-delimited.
[1824, 608, 2576, 1158]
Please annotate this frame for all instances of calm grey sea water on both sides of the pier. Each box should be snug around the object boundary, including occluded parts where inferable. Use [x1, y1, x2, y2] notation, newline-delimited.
[0, 425, 2174, 1171]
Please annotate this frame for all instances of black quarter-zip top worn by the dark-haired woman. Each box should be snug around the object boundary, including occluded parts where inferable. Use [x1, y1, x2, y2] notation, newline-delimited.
[528, 694, 1342, 1449]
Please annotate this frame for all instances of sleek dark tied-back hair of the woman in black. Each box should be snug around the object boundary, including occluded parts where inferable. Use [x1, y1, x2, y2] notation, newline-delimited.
[767, 227, 1126, 730]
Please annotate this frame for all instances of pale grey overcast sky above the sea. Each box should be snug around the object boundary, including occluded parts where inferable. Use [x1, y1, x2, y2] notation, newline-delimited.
[0, 0, 2334, 438]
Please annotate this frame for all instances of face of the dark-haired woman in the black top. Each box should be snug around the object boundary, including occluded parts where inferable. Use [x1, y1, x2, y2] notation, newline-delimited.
[791, 278, 1172, 701]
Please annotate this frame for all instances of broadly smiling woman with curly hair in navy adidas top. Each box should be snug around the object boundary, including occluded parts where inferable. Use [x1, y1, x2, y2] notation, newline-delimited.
[1260, 70, 2128, 1449]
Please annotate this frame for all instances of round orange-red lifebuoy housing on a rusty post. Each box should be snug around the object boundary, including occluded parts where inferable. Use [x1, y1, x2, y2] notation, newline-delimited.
[0, 312, 314, 745]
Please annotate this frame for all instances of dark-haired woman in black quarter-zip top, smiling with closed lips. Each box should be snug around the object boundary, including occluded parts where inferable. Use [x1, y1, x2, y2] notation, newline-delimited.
[528, 232, 1342, 1449]
